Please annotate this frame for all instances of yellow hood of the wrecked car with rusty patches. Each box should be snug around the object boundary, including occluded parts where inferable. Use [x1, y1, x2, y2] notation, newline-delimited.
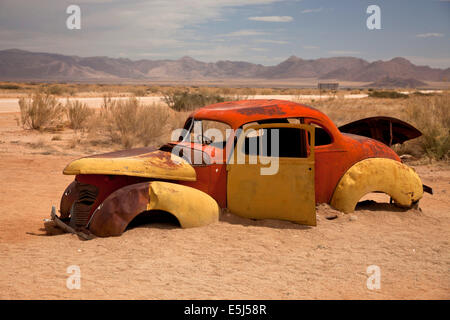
[63, 148, 196, 181]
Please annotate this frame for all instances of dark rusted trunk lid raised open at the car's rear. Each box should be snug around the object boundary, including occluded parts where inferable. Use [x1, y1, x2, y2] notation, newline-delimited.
[339, 117, 422, 146]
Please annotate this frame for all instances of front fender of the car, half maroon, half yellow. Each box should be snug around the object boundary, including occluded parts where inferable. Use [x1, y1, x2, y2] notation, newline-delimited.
[88, 181, 219, 237]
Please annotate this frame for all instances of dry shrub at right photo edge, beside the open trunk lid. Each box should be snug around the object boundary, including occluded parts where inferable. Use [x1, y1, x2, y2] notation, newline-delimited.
[405, 94, 450, 160]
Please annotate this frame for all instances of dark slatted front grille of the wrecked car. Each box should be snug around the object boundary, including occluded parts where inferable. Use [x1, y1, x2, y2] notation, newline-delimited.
[70, 183, 98, 227]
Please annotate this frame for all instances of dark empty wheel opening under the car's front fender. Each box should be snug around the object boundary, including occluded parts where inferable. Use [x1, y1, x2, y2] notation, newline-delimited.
[126, 210, 181, 230]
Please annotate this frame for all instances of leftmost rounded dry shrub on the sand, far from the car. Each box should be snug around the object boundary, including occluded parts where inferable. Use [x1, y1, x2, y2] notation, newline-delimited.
[19, 91, 63, 130]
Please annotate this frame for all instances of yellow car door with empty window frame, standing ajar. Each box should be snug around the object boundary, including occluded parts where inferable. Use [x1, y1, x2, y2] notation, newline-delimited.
[227, 123, 316, 226]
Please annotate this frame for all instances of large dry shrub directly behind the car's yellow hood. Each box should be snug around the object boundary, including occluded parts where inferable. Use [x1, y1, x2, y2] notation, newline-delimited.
[100, 97, 170, 148]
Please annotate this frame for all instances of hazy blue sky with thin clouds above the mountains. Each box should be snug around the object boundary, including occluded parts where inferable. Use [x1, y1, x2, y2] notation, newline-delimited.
[0, 0, 450, 68]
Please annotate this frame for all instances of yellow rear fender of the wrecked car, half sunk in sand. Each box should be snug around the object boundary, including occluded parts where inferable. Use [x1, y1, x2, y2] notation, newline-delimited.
[331, 158, 423, 213]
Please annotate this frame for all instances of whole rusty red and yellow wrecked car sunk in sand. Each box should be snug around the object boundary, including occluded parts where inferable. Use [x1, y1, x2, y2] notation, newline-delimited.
[45, 100, 423, 238]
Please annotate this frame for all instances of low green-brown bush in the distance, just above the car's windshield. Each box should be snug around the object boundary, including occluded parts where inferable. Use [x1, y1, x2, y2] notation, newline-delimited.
[163, 91, 225, 111]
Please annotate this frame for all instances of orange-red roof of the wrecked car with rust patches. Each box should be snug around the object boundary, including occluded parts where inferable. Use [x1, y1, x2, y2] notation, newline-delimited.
[190, 99, 331, 128]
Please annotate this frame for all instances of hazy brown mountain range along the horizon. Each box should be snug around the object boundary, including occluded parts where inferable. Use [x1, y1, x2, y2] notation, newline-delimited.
[0, 49, 450, 82]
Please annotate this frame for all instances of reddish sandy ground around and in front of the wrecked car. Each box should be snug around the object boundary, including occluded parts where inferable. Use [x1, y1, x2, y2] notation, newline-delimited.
[0, 110, 450, 299]
